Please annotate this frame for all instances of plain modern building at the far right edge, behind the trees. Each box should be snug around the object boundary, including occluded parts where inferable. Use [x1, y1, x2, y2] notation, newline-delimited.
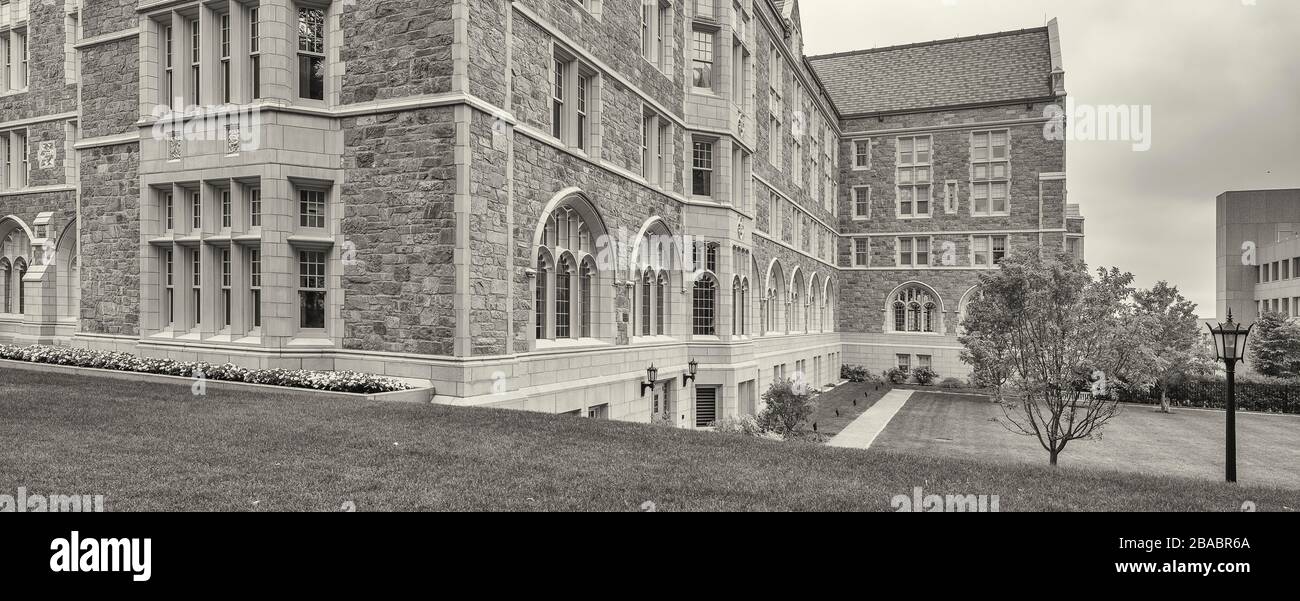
[1216, 189, 1300, 323]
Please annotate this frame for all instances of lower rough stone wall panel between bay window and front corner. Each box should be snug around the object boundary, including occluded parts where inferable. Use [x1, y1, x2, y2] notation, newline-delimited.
[342, 108, 456, 355]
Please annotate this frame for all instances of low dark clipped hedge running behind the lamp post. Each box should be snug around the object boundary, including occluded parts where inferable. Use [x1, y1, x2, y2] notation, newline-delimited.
[1114, 380, 1300, 414]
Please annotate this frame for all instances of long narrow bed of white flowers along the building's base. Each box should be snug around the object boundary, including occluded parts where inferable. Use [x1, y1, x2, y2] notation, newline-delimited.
[0, 345, 412, 394]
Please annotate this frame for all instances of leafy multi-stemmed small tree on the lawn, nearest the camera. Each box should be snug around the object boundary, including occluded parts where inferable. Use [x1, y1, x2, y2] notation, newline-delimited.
[959, 250, 1136, 466]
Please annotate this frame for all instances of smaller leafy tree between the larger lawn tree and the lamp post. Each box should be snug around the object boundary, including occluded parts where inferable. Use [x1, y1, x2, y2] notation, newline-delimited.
[1128, 281, 1214, 414]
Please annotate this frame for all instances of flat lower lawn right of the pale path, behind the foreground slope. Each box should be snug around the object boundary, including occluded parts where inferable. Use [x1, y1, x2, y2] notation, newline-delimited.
[872, 392, 1300, 491]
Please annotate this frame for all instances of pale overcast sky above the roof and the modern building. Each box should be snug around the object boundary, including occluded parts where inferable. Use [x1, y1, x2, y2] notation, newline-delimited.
[800, 0, 1300, 316]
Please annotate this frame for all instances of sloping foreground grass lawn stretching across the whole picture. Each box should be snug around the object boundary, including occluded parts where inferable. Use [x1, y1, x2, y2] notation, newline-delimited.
[0, 369, 1300, 511]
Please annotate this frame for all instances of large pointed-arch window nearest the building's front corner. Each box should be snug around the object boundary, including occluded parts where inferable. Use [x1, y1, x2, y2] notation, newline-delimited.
[533, 196, 601, 340]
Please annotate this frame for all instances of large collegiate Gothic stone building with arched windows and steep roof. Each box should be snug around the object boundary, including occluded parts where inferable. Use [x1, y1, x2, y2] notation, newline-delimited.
[0, 0, 1083, 427]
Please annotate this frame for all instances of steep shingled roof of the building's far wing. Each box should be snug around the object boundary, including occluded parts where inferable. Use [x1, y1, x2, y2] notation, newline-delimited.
[807, 27, 1053, 116]
